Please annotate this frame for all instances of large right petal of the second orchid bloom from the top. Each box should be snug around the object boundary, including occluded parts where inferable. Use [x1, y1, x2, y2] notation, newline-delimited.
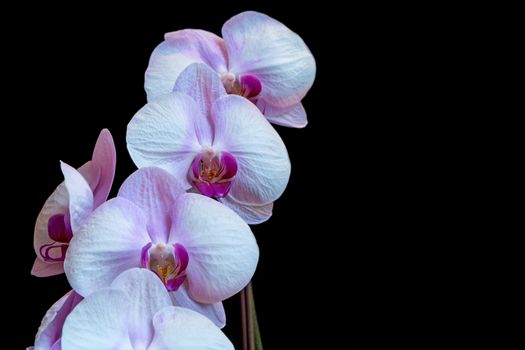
[212, 95, 291, 206]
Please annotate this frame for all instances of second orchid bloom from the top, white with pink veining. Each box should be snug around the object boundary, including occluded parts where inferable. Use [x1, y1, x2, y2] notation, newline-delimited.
[127, 63, 290, 224]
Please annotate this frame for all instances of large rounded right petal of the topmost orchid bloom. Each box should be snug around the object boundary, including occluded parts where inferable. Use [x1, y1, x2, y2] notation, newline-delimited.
[222, 11, 316, 107]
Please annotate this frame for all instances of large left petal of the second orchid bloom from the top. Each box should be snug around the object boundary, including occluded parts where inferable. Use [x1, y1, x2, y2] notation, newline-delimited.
[126, 93, 203, 189]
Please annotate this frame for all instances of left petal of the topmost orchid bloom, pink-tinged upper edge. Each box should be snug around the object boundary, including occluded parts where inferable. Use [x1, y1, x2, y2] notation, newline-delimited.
[144, 29, 227, 101]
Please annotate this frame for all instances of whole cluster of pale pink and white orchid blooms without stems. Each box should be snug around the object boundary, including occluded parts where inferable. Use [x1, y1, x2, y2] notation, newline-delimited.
[32, 12, 315, 350]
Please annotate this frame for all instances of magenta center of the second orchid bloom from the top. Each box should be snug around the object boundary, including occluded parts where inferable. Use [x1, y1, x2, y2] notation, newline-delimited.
[190, 148, 237, 198]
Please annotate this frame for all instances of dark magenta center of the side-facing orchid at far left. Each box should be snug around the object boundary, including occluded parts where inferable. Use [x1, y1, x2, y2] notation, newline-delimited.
[39, 213, 73, 262]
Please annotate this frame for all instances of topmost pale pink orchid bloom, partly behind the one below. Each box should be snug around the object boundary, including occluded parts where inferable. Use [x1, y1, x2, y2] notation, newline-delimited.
[145, 11, 316, 128]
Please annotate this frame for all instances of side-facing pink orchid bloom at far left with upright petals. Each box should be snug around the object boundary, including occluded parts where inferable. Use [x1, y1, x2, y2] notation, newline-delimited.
[31, 129, 116, 277]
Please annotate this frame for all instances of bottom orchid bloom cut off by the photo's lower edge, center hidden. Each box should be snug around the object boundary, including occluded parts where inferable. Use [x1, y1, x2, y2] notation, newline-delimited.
[62, 268, 233, 350]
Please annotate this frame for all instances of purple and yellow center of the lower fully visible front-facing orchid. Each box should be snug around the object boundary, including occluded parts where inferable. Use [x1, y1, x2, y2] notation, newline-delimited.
[140, 242, 189, 292]
